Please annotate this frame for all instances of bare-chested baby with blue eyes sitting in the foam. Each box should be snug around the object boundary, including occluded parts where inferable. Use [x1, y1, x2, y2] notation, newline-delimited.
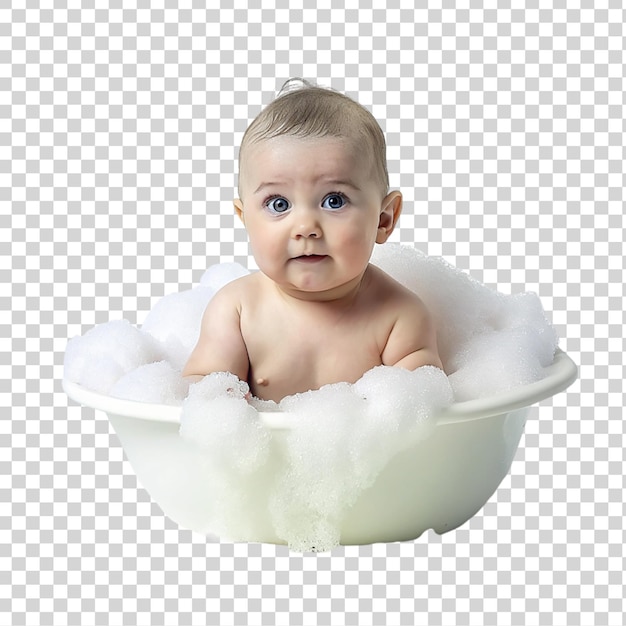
[183, 81, 441, 401]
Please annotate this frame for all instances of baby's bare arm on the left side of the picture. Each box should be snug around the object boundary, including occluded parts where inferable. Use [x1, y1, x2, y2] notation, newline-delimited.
[183, 284, 249, 381]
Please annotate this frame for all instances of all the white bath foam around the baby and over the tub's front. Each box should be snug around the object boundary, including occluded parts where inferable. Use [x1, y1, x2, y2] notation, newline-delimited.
[65, 244, 557, 550]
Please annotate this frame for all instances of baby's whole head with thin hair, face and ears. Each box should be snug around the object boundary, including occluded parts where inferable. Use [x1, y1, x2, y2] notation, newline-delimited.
[235, 83, 402, 299]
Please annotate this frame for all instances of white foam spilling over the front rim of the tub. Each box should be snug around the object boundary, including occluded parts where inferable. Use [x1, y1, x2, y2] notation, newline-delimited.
[173, 366, 452, 551]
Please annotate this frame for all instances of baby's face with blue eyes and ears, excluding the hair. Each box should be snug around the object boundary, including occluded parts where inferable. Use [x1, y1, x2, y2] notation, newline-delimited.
[235, 136, 401, 299]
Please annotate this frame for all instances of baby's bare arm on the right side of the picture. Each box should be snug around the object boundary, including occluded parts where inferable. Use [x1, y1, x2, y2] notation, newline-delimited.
[382, 298, 443, 370]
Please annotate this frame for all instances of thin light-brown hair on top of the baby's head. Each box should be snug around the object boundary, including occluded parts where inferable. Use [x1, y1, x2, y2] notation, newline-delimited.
[239, 79, 389, 195]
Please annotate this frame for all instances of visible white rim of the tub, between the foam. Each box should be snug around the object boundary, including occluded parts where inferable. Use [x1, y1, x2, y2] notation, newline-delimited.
[63, 349, 578, 429]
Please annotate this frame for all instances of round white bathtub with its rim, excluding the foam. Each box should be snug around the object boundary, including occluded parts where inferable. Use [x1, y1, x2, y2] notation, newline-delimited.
[63, 351, 577, 545]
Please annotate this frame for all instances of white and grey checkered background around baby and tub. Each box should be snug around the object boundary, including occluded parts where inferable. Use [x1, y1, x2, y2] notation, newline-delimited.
[0, 0, 626, 626]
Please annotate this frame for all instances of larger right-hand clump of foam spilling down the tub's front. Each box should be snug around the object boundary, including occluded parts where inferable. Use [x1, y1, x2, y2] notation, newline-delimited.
[270, 366, 453, 551]
